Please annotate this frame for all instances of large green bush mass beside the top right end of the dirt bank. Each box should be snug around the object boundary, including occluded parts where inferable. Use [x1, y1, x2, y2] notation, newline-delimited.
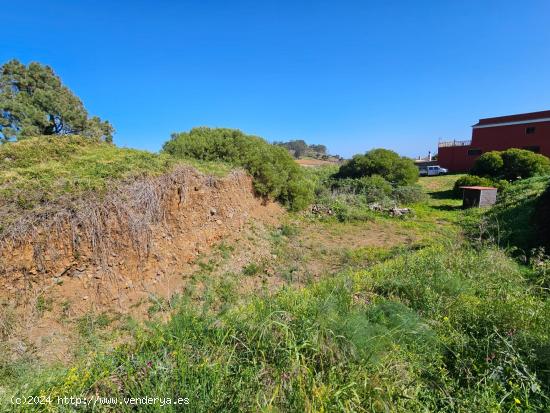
[163, 127, 313, 210]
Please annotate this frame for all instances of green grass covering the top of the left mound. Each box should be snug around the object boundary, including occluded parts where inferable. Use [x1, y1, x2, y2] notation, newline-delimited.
[0, 136, 231, 233]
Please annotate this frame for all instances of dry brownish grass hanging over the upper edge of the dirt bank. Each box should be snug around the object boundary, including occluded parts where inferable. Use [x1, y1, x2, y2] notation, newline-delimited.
[0, 167, 224, 269]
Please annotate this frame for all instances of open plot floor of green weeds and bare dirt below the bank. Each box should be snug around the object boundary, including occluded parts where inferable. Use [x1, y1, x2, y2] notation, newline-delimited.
[0, 172, 550, 412]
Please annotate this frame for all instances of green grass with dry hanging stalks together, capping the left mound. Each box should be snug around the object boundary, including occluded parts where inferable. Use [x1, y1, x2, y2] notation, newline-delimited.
[0, 136, 236, 271]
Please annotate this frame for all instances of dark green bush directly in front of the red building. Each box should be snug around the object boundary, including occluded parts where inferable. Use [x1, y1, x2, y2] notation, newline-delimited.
[472, 148, 550, 181]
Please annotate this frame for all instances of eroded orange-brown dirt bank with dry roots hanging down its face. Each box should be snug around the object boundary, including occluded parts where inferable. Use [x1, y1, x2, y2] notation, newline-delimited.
[0, 168, 282, 359]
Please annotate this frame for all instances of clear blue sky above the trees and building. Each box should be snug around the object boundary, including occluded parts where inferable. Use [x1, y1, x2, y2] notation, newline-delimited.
[0, 0, 550, 156]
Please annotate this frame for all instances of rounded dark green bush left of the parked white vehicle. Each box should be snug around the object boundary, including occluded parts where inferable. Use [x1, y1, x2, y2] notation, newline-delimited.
[336, 149, 418, 186]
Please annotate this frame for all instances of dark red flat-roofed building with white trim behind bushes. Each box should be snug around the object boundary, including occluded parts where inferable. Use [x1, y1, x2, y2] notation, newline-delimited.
[438, 110, 550, 172]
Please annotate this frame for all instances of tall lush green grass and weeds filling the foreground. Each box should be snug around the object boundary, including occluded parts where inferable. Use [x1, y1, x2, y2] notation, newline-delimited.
[3, 245, 550, 412]
